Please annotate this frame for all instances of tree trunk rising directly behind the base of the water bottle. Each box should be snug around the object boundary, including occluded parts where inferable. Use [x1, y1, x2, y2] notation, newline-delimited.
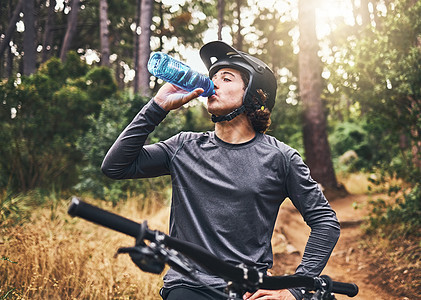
[137, 0, 153, 96]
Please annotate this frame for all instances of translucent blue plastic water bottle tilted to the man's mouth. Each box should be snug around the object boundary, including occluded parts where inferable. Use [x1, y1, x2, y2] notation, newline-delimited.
[148, 52, 215, 97]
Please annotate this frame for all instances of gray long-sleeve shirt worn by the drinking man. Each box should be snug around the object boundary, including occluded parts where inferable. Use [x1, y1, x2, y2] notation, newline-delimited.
[102, 100, 340, 296]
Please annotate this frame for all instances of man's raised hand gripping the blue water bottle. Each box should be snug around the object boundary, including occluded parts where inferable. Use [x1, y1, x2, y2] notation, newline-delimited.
[154, 82, 204, 111]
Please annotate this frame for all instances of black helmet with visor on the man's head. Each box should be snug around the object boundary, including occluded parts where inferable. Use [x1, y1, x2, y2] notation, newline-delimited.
[200, 41, 277, 120]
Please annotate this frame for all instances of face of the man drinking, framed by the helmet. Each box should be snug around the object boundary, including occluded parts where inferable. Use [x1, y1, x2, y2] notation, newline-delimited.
[208, 68, 245, 116]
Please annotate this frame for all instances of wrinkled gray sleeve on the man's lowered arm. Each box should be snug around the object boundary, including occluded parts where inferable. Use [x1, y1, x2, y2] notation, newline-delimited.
[287, 152, 340, 276]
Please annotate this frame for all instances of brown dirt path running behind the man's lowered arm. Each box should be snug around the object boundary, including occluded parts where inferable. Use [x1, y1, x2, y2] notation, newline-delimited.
[273, 195, 388, 300]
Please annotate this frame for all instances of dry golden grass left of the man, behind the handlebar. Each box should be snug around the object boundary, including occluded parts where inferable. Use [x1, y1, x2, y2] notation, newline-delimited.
[0, 199, 168, 299]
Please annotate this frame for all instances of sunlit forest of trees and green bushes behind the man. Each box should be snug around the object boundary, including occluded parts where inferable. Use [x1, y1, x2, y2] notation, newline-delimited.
[0, 0, 421, 297]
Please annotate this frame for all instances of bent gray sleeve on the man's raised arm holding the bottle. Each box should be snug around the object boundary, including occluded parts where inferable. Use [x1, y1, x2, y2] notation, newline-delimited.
[101, 100, 169, 179]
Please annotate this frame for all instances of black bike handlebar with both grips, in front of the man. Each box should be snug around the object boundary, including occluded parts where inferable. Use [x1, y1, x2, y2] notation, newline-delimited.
[68, 197, 358, 297]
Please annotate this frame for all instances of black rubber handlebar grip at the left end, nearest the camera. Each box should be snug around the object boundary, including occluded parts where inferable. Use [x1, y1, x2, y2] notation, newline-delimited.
[68, 197, 141, 238]
